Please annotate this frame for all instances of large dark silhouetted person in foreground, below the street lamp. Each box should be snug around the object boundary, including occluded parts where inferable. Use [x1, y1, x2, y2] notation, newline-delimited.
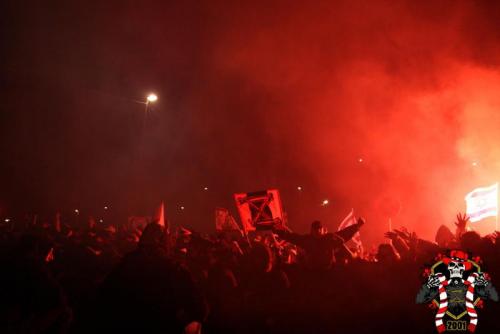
[89, 223, 206, 333]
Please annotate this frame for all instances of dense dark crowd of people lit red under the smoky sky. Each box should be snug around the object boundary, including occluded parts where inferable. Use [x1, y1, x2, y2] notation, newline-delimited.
[0, 216, 500, 333]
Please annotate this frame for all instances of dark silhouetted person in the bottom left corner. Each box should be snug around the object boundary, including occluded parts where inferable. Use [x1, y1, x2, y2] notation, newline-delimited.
[0, 234, 71, 333]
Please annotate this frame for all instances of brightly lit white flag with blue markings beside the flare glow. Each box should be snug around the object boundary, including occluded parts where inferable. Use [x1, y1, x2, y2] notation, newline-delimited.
[465, 183, 498, 223]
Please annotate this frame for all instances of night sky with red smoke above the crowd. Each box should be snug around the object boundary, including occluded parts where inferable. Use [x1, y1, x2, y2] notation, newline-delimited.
[0, 0, 500, 239]
